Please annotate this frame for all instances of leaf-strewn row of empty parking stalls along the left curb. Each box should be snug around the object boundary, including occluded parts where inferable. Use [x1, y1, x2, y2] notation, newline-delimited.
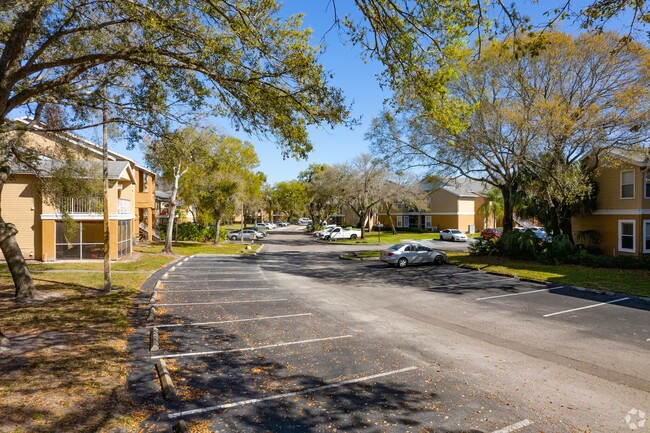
[132, 257, 552, 432]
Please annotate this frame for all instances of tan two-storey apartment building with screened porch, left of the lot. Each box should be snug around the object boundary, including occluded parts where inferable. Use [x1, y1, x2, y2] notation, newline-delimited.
[0, 120, 155, 261]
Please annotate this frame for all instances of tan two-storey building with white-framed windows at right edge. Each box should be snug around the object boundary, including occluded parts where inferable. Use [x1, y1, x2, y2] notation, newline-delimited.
[572, 152, 650, 255]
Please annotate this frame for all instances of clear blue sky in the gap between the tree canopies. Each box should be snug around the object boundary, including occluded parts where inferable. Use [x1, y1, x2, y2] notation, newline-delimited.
[105, 0, 632, 185]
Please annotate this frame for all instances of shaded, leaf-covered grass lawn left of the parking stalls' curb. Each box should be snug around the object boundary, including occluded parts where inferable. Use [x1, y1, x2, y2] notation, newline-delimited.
[0, 242, 259, 433]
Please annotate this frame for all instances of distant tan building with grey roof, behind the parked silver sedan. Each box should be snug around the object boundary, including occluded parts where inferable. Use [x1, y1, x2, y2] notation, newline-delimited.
[379, 178, 486, 232]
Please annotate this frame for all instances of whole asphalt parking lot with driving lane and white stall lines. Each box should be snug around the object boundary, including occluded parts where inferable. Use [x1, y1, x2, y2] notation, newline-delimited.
[128, 224, 650, 433]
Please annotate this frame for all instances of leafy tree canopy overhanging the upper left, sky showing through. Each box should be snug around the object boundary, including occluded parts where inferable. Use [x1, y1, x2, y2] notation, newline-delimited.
[0, 0, 348, 157]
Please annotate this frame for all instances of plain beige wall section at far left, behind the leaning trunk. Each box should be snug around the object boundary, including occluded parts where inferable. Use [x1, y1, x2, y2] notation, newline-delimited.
[0, 175, 42, 260]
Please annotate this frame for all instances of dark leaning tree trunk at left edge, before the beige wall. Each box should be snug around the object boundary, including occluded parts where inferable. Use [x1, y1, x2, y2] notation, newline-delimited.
[0, 219, 36, 299]
